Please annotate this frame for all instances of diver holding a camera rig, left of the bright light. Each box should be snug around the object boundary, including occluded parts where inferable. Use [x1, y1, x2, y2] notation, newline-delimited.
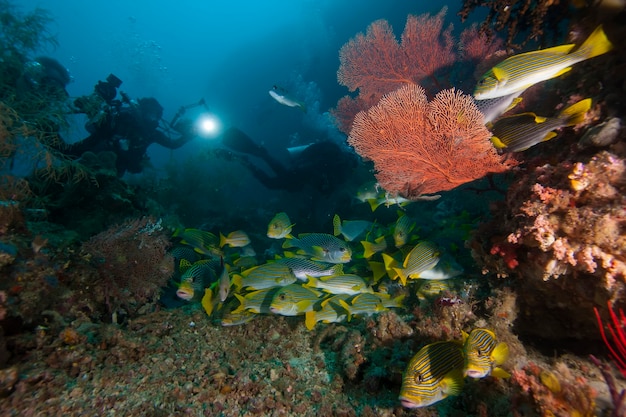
[59, 74, 196, 177]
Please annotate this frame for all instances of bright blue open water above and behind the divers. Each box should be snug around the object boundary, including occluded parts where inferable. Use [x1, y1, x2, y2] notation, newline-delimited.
[20, 0, 448, 166]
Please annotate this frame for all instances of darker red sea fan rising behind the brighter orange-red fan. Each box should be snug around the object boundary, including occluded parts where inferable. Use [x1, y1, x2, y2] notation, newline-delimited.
[331, 7, 501, 134]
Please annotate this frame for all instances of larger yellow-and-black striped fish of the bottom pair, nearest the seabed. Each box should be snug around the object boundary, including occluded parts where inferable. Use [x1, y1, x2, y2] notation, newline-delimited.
[399, 341, 464, 408]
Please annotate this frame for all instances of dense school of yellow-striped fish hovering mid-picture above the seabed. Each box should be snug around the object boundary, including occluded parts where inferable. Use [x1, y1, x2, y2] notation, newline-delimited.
[171, 212, 463, 330]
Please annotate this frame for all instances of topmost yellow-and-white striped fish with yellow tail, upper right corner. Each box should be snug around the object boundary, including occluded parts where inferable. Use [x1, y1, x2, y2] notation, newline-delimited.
[474, 25, 613, 100]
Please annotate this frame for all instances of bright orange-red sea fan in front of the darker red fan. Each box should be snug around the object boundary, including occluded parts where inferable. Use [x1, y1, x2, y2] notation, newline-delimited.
[348, 84, 513, 198]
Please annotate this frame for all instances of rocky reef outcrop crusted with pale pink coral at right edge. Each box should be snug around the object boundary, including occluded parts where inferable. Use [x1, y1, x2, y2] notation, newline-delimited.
[471, 142, 626, 340]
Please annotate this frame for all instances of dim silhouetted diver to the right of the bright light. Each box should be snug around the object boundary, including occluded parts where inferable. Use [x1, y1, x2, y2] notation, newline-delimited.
[222, 127, 357, 195]
